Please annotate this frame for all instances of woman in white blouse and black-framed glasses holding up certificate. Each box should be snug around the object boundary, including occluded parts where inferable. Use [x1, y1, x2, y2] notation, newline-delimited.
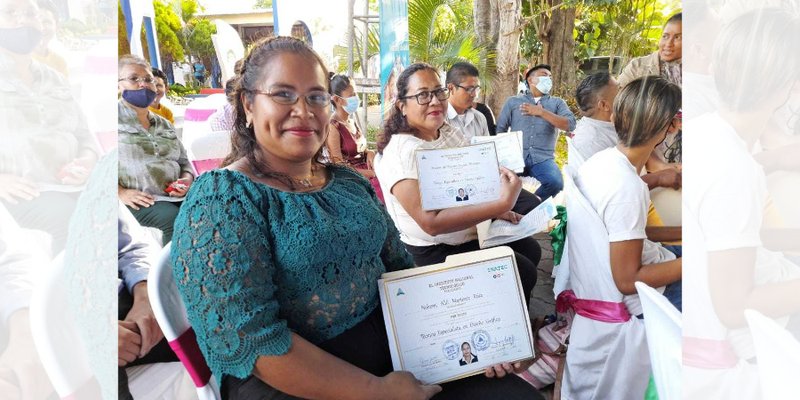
[375, 63, 541, 298]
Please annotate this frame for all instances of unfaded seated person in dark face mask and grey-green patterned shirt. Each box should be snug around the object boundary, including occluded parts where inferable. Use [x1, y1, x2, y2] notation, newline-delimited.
[117, 55, 194, 244]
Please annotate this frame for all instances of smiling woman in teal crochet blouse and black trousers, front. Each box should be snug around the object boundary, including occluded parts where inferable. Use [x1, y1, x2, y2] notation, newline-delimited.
[172, 37, 537, 399]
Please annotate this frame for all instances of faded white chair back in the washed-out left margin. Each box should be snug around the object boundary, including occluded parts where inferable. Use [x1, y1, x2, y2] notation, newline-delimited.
[30, 253, 101, 399]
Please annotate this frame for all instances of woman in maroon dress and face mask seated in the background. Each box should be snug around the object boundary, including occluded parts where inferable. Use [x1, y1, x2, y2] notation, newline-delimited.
[325, 72, 383, 202]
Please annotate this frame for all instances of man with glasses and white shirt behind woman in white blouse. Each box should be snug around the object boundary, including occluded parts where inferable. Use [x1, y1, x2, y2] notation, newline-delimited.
[445, 62, 489, 141]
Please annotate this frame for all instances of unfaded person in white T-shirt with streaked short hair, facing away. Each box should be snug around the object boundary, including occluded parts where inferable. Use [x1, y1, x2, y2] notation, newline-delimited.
[575, 77, 681, 310]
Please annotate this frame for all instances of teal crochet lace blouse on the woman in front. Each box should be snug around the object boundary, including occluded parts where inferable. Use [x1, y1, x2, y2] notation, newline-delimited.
[171, 166, 413, 379]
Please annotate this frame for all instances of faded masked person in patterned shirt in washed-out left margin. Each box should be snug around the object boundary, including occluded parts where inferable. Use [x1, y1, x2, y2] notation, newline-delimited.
[0, 0, 98, 254]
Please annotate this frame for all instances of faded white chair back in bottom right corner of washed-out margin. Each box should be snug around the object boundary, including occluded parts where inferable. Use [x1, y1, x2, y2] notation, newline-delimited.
[744, 310, 800, 400]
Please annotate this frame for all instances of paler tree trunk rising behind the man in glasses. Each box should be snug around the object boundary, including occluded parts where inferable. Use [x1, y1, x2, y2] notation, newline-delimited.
[487, 0, 522, 115]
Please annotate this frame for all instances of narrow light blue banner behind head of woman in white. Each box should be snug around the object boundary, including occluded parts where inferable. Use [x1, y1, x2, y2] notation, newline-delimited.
[380, 0, 409, 116]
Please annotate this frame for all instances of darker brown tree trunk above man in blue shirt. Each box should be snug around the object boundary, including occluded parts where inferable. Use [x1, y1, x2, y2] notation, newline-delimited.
[539, 0, 576, 97]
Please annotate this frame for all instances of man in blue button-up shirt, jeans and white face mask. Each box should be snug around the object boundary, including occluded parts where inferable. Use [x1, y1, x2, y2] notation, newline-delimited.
[497, 64, 575, 200]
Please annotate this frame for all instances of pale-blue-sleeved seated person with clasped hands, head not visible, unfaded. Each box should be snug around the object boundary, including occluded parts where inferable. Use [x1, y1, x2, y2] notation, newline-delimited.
[117, 203, 178, 399]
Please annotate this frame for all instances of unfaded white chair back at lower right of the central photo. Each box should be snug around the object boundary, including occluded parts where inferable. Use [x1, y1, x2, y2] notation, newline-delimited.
[634, 282, 682, 400]
